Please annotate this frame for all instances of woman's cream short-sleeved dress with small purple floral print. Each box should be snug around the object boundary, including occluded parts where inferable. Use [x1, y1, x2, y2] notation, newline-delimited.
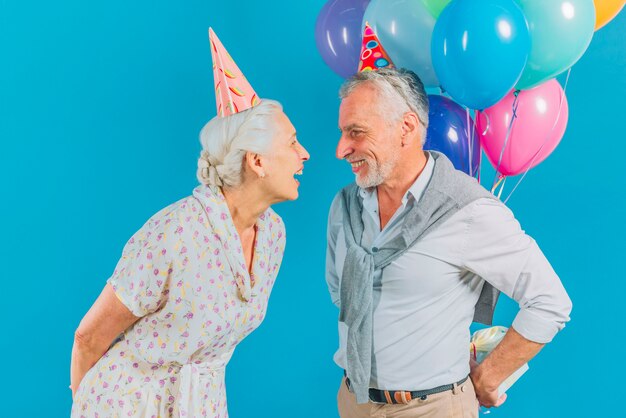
[72, 186, 285, 418]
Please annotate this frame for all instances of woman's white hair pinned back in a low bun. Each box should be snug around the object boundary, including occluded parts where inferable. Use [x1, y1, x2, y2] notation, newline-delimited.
[197, 99, 283, 188]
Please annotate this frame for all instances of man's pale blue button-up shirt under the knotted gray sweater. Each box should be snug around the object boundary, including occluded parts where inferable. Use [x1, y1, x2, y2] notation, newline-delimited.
[326, 158, 571, 390]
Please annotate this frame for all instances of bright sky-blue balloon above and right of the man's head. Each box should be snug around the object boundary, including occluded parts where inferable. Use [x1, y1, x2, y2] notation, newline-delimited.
[431, 0, 530, 110]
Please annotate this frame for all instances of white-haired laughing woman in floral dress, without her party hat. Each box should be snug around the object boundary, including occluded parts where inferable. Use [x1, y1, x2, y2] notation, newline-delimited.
[71, 30, 309, 418]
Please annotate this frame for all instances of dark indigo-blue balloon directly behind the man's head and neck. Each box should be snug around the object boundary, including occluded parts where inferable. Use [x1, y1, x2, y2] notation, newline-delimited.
[424, 95, 480, 176]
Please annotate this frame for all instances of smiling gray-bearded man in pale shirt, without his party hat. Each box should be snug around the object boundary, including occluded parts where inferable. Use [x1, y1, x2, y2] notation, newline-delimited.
[326, 69, 571, 418]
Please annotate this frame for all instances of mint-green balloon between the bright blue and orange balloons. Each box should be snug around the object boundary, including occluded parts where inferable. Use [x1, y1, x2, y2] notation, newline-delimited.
[515, 0, 596, 90]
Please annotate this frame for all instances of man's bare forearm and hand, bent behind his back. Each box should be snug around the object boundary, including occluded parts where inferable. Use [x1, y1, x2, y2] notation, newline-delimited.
[471, 328, 545, 406]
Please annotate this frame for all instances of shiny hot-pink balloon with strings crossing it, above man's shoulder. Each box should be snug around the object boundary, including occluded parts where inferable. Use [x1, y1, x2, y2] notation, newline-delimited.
[476, 79, 568, 176]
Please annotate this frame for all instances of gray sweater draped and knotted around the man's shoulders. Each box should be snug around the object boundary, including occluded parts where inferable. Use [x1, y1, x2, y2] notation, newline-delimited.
[339, 151, 499, 403]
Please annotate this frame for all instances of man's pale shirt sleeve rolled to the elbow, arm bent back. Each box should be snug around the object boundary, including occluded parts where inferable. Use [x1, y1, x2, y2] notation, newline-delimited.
[464, 199, 572, 343]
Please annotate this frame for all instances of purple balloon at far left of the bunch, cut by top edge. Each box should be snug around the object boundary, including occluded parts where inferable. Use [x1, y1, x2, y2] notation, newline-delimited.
[315, 0, 370, 78]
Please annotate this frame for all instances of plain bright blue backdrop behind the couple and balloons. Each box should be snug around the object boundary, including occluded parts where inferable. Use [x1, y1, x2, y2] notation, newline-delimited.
[0, 0, 626, 418]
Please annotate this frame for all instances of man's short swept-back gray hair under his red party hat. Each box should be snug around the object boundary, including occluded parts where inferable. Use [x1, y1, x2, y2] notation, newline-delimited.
[339, 68, 428, 145]
